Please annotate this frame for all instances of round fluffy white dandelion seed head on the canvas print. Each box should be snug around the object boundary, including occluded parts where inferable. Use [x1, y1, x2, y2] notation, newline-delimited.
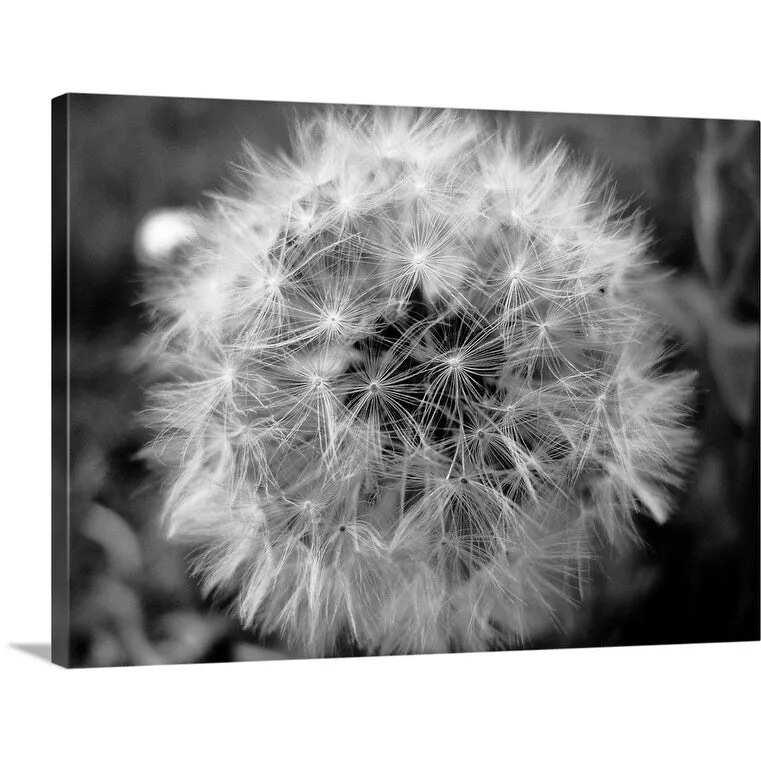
[141, 109, 691, 654]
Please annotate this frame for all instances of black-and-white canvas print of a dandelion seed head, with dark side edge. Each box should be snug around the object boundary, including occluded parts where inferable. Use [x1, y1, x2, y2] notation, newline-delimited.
[53, 95, 759, 666]
